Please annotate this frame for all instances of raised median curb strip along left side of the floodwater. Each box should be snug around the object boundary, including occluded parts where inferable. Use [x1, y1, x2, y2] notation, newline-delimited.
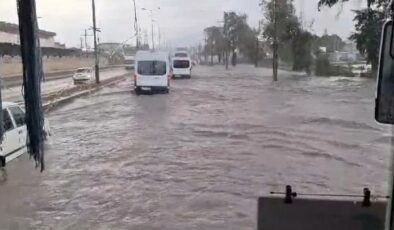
[43, 74, 130, 112]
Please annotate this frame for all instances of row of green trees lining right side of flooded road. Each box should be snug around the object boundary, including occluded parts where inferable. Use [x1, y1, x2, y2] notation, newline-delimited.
[199, 0, 389, 80]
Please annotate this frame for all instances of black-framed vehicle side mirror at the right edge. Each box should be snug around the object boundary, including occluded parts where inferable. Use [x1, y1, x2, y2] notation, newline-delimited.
[375, 20, 394, 124]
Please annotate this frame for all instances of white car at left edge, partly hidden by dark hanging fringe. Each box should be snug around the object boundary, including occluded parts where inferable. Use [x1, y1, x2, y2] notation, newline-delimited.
[0, 102, 50, 167]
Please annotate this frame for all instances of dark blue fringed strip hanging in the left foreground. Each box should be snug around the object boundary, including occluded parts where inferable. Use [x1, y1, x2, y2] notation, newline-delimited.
[16, 0, 45, 172]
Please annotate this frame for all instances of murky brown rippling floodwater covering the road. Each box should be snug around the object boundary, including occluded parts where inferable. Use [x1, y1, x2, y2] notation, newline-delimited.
[0, 65, 390, 230]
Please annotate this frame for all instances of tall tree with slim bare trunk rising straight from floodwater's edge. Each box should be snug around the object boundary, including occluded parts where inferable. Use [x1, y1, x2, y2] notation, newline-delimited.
[261, 0, 300, 81]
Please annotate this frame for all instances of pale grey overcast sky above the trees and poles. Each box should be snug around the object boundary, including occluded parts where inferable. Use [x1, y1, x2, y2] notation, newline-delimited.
[0, 0, 365, 47]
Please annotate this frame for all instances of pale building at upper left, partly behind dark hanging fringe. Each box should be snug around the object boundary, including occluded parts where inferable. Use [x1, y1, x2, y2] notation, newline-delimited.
[0, 21, 58, 48]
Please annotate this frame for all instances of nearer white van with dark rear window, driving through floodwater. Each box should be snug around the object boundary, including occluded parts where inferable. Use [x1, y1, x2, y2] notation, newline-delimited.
[134, 51, 171, 94]
